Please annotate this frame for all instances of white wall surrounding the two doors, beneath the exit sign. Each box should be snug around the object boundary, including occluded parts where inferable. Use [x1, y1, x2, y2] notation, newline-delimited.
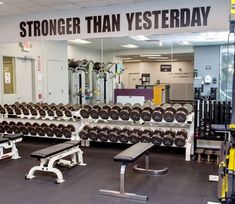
[0, 41, 68, 103]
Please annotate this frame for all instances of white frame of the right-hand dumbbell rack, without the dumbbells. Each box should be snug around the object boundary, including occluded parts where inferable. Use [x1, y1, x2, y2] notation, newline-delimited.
[80, 112, 194, 161]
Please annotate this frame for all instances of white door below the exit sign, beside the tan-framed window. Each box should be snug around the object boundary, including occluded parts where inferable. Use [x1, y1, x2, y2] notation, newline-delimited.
[15, 58, 34, 103]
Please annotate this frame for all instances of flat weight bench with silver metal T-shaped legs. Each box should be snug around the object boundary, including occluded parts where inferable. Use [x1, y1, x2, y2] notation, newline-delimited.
[99, 143, 168, 201]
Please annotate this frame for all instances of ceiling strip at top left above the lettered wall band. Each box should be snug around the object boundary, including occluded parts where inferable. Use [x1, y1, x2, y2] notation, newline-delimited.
[0, 0, 154, 16]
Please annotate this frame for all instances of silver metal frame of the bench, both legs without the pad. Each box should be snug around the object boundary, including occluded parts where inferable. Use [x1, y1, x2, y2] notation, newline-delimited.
[99, 148, 168, 201]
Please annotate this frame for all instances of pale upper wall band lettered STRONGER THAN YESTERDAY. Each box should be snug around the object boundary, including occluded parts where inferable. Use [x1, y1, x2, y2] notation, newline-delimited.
[0, 0, 230, 43]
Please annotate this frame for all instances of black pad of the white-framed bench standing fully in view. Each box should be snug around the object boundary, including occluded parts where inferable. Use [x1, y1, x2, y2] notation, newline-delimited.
[30, 141, 79, 159]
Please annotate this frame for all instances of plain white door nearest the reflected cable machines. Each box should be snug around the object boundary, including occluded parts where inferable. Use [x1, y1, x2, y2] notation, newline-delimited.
[47, 60, 64, 104]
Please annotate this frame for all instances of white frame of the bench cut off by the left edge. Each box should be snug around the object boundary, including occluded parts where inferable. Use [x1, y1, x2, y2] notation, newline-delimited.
[0, 137, 22, 160]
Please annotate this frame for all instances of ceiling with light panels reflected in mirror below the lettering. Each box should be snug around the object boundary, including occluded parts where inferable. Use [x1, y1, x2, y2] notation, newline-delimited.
[69, 32, 228, 51]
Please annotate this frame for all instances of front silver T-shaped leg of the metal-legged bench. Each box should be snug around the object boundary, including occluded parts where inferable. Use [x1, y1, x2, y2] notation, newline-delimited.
[99, 162, 148, 201]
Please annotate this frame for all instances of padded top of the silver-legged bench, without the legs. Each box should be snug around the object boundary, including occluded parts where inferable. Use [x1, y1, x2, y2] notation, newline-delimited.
[113, 143, 154, 162]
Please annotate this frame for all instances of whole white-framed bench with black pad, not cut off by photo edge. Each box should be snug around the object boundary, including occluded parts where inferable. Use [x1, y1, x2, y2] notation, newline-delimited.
[25, 140, 86, 183]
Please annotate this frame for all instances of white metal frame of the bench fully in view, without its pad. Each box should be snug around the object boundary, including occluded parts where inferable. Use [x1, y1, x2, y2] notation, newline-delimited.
[25, 146, 86, 184]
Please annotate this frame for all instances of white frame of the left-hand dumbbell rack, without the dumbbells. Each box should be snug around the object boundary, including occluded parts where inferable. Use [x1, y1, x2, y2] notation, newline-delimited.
[0, 111, 80, 140]
